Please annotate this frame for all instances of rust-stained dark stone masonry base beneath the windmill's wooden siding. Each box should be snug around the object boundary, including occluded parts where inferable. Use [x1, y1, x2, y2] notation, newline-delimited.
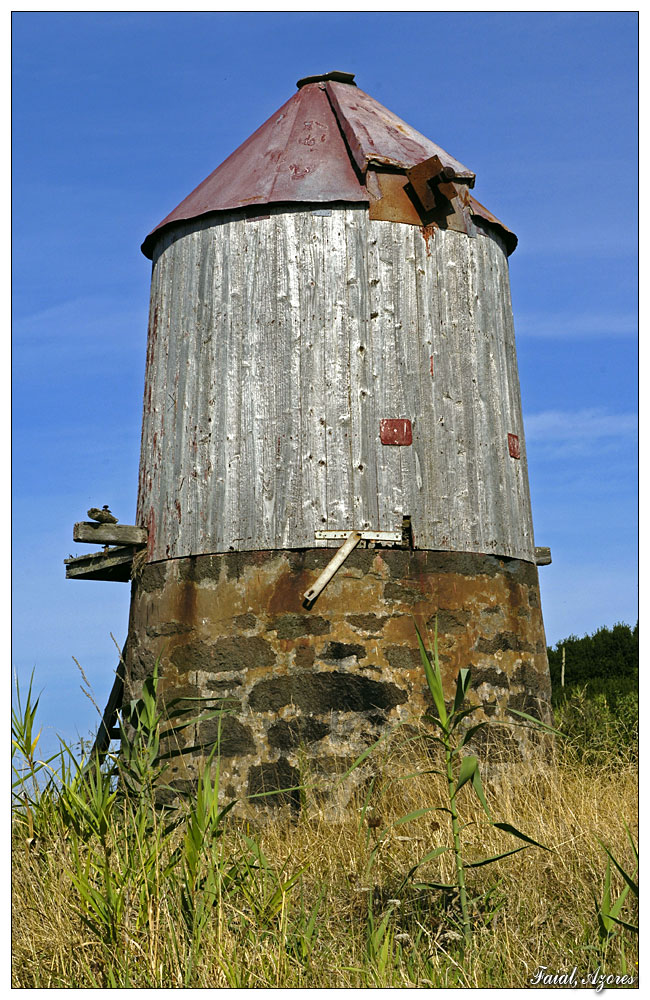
[125, 548, 550, 817]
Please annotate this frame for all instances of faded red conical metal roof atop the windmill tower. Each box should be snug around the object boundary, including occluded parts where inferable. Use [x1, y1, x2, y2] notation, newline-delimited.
[142, 70, 508, 258]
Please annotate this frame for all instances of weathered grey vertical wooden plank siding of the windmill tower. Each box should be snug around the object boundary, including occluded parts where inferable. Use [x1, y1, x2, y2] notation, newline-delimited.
[138, 206, 534, 562]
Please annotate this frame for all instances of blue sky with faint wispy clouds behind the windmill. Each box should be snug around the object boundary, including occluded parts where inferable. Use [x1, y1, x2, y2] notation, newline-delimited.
[12, 13, 637, 747]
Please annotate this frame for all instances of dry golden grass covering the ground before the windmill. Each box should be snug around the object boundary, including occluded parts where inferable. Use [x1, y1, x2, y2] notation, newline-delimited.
[13, 732, 637, 988]
